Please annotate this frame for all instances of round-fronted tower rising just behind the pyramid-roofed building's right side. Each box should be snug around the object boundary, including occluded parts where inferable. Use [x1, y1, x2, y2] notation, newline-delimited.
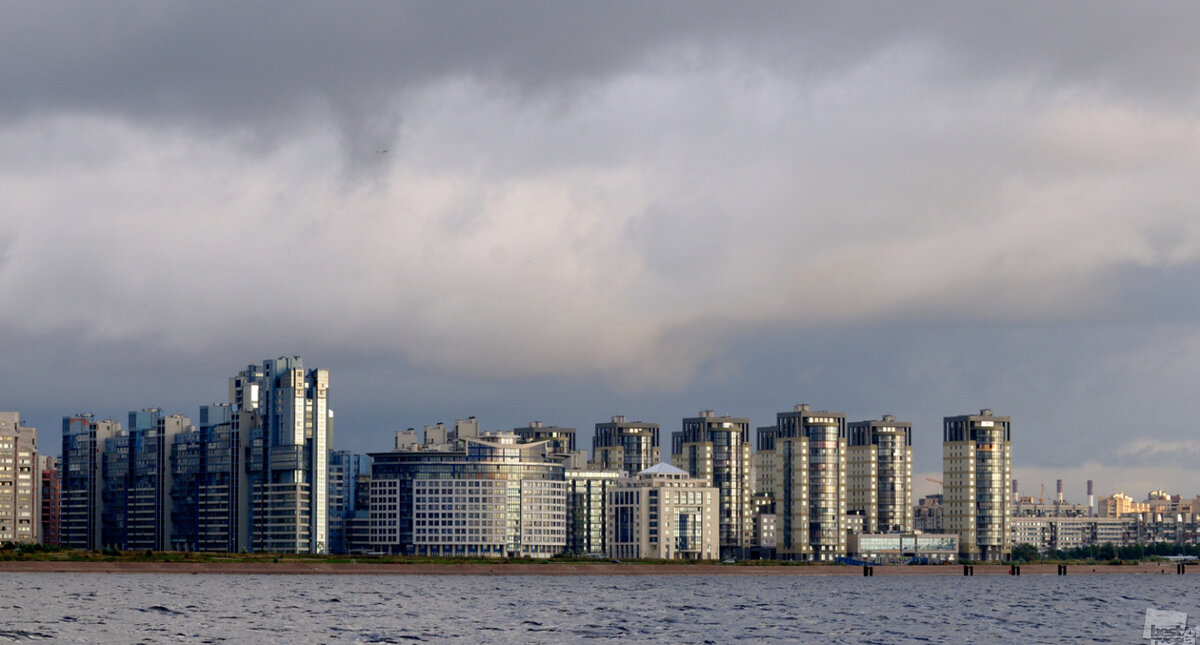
[671, 410, 754, 557]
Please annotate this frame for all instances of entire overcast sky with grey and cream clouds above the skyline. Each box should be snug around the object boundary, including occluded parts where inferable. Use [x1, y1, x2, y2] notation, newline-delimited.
[0, 1, 1200, 500]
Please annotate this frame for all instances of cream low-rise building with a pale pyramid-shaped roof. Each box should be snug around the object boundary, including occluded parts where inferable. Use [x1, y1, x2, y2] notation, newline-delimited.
[608, 464, 719, 560]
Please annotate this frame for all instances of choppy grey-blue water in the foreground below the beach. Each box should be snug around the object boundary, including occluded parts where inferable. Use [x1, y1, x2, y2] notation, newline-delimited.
[0, 573, 1200, 644]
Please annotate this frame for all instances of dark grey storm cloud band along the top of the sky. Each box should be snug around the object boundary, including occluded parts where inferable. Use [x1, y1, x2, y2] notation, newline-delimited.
[0, 2, 1200, 126]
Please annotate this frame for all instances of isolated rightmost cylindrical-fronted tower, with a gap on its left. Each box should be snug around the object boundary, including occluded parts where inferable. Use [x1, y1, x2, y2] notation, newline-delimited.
[942, 410, 1013, 560]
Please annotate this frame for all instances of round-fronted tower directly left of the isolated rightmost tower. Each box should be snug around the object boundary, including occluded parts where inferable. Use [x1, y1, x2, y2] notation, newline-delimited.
[846, 415, 913, 534]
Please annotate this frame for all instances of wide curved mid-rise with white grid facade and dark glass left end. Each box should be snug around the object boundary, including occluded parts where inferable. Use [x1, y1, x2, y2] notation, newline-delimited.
[370, 433, 566, 557]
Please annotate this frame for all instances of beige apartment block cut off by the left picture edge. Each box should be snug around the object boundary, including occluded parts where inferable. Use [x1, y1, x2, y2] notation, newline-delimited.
[0, 412, 42, 543]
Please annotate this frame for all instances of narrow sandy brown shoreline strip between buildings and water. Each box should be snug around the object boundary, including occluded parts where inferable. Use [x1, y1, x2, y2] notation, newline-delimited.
[0, 560, 1180, 577]
